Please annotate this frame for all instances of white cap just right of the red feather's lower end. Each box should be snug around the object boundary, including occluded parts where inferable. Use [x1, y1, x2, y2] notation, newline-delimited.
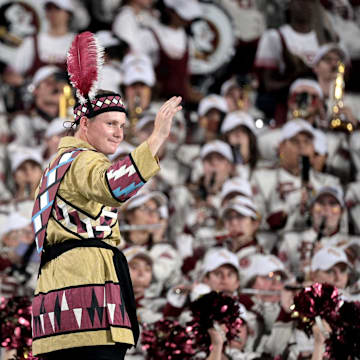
[123, 54, 155, 87]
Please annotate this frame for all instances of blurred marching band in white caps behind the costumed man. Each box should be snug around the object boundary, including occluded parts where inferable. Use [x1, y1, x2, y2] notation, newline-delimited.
[0, 0, 360, 359]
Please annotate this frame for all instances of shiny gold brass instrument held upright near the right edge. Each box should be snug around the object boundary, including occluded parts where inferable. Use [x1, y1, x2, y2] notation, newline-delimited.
[329, 61, 354, 133]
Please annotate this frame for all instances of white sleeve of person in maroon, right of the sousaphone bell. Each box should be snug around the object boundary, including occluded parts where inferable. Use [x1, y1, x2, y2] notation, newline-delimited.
[255, 29, 282, 69]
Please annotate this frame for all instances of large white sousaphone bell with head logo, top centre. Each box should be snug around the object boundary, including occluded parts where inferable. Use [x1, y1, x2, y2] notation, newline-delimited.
[190, 1, 235, 75]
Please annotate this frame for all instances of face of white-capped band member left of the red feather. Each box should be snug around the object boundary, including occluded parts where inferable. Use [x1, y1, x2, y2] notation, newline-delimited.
[34, 76, 66, 118]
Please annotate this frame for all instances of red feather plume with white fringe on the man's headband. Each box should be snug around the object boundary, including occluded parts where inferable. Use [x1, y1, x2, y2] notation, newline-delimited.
[67, 31, 104, 104]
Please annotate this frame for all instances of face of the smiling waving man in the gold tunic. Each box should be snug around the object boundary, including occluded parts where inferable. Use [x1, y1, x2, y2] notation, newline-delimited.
[80, 111, 126, 155]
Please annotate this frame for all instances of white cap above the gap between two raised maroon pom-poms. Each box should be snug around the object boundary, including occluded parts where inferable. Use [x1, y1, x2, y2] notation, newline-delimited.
[239, 254, 287, 287]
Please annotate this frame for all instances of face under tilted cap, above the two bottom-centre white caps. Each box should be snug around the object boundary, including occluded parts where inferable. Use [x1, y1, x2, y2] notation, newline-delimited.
[224, 210, 258, 237]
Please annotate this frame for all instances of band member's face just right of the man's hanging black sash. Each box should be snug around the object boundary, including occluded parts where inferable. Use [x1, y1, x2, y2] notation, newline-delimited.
[129, 257, 152, 296]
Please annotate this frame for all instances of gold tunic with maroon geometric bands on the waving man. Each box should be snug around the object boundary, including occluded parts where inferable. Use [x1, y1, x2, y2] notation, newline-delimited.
[32, 137, 159, 355]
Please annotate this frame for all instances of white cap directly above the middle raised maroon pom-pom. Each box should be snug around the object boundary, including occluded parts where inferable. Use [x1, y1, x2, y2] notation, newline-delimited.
[201, 248, 239, 275]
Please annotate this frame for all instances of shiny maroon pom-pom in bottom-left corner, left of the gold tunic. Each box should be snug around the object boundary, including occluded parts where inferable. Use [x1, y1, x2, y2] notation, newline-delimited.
[0, 296, 36, 360]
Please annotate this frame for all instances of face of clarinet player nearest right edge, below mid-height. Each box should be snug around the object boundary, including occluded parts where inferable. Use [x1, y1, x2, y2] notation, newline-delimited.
[311, 194, 342, 235]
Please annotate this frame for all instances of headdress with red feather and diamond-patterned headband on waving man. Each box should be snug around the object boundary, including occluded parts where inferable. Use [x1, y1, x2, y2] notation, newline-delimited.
[67, 31, 126, 125]
